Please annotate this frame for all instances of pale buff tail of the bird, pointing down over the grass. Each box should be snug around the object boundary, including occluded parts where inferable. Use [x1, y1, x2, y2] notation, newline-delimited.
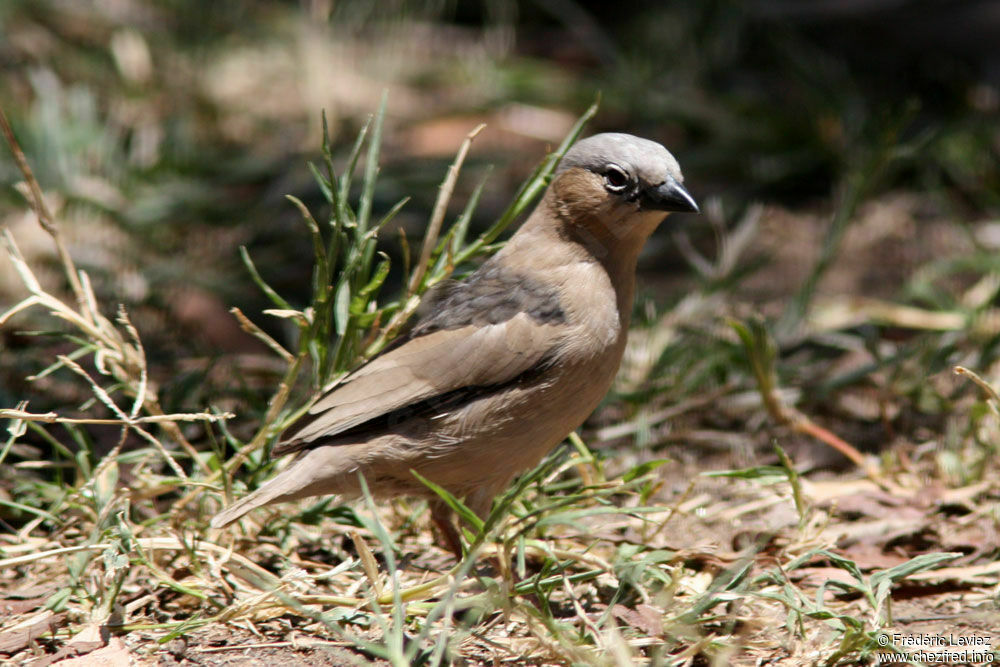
[211, 447, 350, 528]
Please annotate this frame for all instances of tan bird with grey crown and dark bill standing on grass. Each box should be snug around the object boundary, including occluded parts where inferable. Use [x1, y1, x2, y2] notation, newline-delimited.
[211, 132, 699, 557]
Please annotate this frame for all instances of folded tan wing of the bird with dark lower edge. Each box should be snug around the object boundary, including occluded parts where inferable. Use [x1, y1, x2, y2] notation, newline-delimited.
[274, 312, 562, 455]
